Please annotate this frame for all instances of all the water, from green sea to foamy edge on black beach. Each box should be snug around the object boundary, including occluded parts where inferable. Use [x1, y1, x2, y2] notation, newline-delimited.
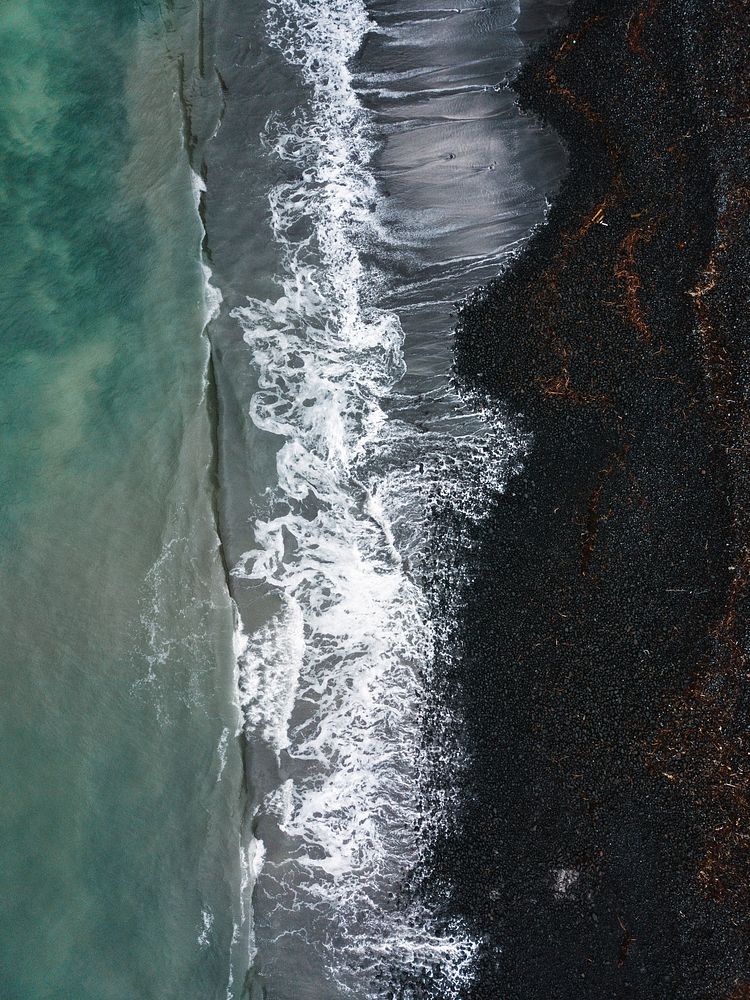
[0, 0, 563, 1000]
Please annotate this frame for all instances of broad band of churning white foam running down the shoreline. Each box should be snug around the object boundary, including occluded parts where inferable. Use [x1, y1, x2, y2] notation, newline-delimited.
[233, 0, 524, 1000]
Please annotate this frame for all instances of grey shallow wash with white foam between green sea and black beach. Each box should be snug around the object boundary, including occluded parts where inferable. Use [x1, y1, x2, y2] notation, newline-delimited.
[206, 0, 562, 998]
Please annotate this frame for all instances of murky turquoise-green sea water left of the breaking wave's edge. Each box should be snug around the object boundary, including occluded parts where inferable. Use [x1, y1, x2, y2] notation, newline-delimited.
[0, 0, 239, 1000]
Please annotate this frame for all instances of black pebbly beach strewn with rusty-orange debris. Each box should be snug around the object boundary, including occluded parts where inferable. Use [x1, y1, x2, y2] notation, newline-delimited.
[438, 0, 750, 1000]
